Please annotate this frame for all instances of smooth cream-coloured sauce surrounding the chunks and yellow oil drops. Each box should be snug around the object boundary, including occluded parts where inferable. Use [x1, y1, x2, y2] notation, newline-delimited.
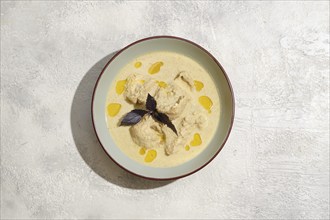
[105, 52, 220, 167]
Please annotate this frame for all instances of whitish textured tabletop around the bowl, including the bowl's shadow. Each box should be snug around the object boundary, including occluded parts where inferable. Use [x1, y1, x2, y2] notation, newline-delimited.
[1, 1, 329, 219]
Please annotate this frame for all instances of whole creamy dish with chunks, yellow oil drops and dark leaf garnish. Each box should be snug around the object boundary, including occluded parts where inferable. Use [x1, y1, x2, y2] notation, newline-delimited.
[105, 51, 220, 167]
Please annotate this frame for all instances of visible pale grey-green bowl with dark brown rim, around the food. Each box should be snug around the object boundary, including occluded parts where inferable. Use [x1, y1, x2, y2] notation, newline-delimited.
[92, 36, 235, 180]
